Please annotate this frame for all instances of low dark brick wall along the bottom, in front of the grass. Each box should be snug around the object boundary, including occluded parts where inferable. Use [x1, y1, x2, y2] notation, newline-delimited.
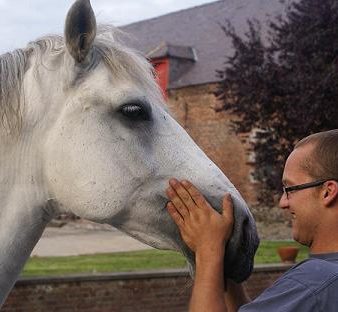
[1, 266, 289, 312]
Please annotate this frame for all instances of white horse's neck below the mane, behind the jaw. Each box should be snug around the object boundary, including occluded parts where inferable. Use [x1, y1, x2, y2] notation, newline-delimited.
[0, 135, 54, 306]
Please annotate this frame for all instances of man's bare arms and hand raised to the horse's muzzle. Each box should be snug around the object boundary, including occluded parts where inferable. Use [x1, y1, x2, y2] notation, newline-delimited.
[167, 179, 248, 312]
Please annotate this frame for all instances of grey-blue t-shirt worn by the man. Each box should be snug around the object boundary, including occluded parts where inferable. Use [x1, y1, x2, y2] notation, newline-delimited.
[239, 253, 338, 312]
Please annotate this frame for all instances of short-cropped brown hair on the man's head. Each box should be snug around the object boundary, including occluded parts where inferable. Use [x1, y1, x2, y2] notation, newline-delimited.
[294, 129, 338, 180]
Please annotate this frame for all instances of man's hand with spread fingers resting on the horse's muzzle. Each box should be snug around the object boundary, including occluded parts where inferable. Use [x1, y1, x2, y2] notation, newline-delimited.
[166, 179, 234, 259]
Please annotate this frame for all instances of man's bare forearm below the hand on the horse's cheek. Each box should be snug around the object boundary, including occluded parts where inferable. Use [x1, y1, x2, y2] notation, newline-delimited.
[189, 248, 226, 312]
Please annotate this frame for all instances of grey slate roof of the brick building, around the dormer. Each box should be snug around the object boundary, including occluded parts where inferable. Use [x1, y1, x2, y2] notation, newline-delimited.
[121, 0, 290, 89]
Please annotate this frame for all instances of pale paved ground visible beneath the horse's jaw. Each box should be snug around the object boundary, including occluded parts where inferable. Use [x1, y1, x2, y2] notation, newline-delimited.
[32, 220, 151, 257]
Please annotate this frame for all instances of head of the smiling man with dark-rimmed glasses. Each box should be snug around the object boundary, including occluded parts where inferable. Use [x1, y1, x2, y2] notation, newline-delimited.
[280, 130, 338, 251]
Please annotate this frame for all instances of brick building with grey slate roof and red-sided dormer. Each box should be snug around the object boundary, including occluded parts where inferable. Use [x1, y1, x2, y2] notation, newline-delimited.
[123, 0, 287, 204]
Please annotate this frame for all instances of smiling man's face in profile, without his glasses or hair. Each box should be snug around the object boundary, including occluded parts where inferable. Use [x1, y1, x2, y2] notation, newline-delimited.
[279, 145, 321, 247]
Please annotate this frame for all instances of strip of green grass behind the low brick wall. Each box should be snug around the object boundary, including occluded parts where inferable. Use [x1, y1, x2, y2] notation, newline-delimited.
[22, 241, 308, 276]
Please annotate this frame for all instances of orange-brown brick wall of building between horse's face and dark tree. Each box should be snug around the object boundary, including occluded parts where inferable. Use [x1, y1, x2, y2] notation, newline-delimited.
[168, 84, 256, 205]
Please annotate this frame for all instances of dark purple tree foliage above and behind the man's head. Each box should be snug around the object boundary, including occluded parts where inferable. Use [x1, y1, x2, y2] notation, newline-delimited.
[216, 0, 338, 206]
